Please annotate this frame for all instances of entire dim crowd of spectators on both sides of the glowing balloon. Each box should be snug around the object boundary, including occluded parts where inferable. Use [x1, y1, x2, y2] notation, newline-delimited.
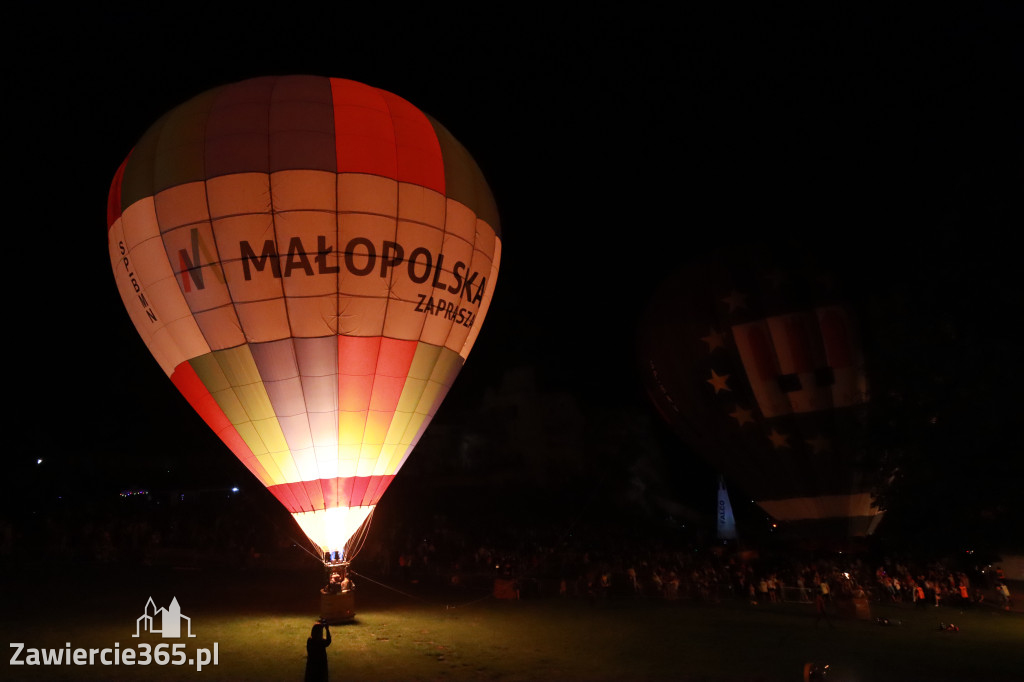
[0, 489, 1012, 608]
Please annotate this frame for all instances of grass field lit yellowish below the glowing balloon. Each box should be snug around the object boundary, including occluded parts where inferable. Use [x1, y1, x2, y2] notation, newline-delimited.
[0, 566, 1024, 682]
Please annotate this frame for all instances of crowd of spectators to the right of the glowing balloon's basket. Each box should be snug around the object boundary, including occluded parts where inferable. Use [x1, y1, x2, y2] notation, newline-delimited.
[360, 509, 1005, 607]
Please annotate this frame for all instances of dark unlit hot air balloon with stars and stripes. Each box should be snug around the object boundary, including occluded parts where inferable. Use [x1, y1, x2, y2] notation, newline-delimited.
[639, 249, 882, 545]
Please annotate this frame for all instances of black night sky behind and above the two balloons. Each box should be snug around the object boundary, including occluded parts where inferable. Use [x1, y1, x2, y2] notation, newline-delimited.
[4, 2, 1024, 548]
